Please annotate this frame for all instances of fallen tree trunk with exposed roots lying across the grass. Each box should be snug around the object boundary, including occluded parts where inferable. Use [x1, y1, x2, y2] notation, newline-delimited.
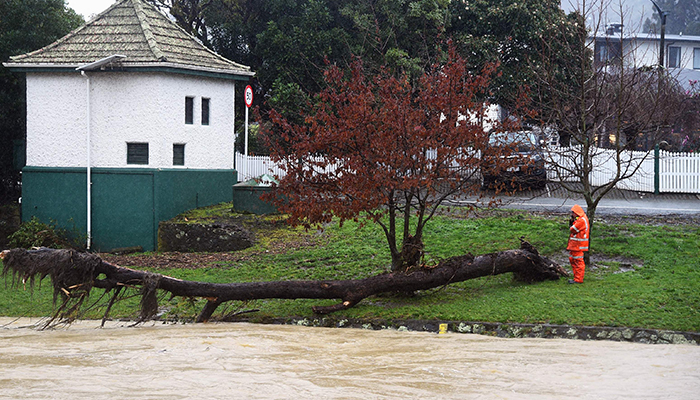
[1, 239, 568, 322]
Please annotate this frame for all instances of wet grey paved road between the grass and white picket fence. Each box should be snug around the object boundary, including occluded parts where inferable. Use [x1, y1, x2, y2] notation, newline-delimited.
[452, 183, 700, 216]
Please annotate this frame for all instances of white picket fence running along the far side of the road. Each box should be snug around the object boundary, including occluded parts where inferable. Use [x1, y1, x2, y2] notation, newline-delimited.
[236, 147, 700, 193]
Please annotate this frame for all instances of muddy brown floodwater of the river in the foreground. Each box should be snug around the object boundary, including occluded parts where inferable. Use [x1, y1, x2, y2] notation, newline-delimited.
[0, 318, 700, 400]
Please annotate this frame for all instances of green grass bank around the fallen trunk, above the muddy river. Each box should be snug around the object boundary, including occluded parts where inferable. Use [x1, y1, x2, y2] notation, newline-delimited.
[0, 211, 700, 332]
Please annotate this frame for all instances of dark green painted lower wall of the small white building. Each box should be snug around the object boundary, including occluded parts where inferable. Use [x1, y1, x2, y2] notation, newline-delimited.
[22, 167, 236, 251]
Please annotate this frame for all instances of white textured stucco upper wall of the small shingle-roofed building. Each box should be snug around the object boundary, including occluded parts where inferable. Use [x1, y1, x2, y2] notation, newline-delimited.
[27, 72, 234, 169]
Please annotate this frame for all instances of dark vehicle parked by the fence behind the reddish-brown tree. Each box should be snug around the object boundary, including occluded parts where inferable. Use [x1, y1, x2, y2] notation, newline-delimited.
[481, 131, 547, 190]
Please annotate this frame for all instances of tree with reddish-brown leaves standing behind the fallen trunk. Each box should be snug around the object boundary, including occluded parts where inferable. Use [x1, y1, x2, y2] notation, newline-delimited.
[265, 46, 516, 271]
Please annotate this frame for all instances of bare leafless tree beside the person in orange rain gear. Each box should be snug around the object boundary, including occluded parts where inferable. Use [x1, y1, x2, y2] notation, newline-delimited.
[533, 0, 683, 256]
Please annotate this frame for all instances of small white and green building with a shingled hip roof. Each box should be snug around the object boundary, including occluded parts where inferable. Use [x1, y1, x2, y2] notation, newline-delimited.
[4, 0, 253, 251]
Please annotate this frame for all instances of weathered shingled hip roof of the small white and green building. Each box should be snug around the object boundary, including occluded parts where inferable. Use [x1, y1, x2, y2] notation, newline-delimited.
[4, 0, 253, 79]
